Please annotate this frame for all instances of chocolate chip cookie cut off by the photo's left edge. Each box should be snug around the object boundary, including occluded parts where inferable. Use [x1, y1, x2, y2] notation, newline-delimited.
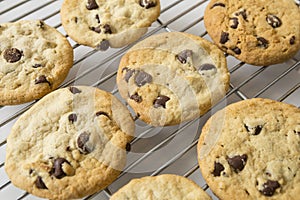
[0, 20, 73, 105]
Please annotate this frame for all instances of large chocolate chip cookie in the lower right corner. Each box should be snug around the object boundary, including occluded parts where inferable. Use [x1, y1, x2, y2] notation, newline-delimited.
[198, 98, 300, 200]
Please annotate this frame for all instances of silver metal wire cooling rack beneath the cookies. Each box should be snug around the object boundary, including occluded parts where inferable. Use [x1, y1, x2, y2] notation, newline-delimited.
[0, 0, 300, 200]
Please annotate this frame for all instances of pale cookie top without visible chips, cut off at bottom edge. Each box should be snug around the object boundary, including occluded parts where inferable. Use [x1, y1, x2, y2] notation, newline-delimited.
[110, 174, 211, 200]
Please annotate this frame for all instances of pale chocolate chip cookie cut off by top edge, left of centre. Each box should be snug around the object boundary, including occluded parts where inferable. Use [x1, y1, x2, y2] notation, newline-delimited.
[61, 0, 160, 50]
